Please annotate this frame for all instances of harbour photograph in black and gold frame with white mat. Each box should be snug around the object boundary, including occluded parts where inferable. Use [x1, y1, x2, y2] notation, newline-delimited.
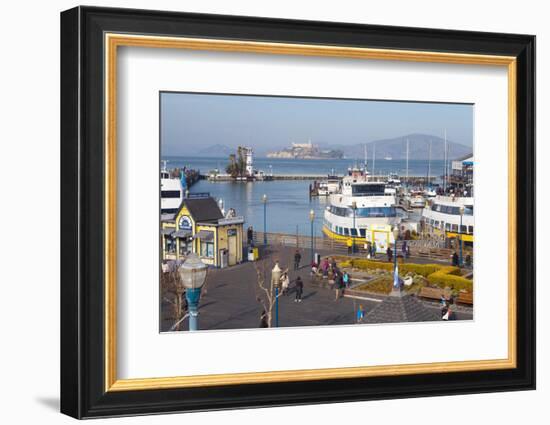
[61, 7, 535, 418]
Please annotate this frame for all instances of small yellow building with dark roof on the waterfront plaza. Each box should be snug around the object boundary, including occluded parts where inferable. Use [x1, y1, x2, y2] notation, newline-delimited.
[160, 194, 244, 267]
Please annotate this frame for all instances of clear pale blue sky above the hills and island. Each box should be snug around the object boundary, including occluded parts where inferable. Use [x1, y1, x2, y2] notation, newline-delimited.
[161, 93, 473, 155]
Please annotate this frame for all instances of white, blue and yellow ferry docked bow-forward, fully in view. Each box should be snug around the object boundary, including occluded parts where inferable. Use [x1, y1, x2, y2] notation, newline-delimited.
[323, 168, 401, 252]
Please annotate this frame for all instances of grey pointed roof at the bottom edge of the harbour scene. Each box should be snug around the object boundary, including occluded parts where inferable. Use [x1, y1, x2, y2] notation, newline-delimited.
[363, 294, 441, 323]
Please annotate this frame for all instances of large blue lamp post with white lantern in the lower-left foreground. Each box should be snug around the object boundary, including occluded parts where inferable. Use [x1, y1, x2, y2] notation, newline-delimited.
[178, 252, 207, 331]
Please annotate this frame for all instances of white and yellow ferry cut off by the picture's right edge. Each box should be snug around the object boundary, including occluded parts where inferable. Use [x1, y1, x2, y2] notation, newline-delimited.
[421, 195, 474, 243]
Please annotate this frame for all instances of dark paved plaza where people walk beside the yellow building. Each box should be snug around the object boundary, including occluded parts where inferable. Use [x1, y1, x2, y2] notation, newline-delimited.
[161, 247, 471, 331]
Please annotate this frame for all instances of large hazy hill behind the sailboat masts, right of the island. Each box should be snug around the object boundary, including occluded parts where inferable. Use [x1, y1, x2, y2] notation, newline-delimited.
[340, 134, 472, 160]
